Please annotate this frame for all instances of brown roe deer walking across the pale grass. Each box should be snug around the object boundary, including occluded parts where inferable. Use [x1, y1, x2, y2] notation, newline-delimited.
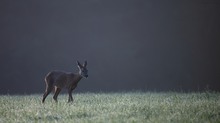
[42, 61, 88, 103]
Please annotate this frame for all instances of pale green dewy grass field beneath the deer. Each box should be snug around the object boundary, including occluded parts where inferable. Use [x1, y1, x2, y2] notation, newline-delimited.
[0, 92, 220, 123]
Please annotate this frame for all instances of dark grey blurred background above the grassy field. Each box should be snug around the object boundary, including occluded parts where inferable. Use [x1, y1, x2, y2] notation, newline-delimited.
[0, 0, 220, 94]
